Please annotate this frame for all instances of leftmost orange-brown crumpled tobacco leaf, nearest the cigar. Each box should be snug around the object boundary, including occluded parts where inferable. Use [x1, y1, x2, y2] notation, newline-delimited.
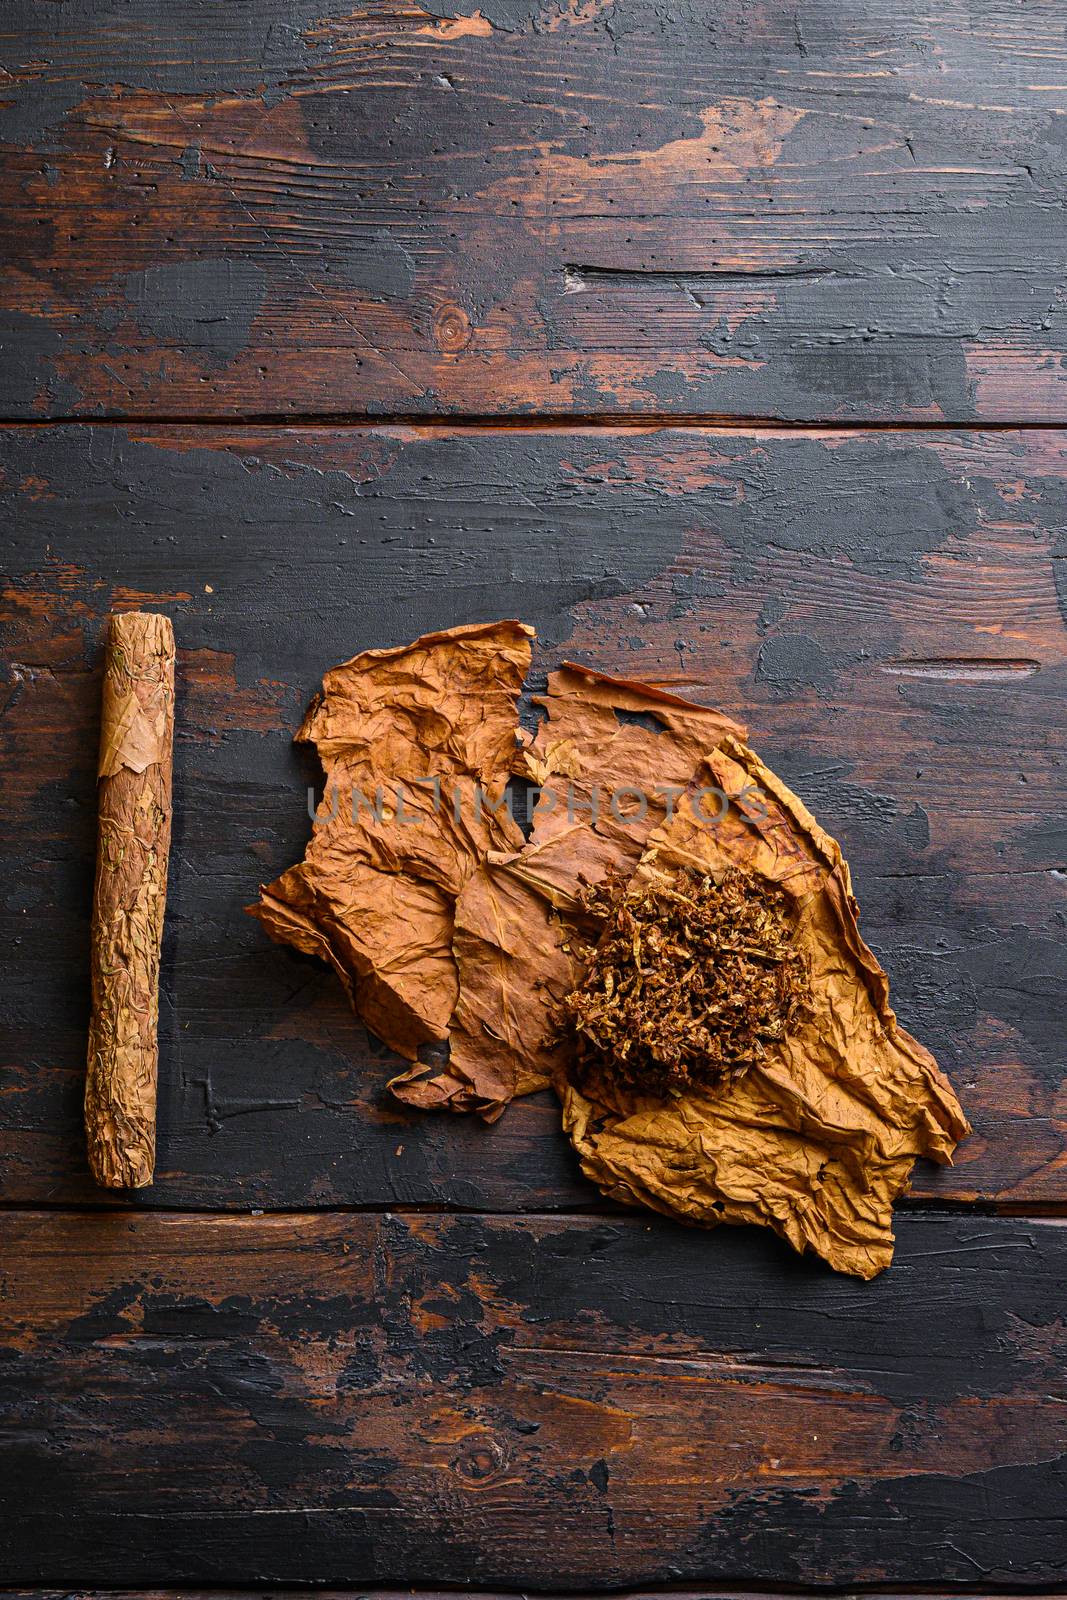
[248, 621, 533, 1061]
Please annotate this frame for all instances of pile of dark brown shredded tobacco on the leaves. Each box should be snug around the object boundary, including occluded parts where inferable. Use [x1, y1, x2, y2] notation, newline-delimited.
[560, 866, 811, 1096]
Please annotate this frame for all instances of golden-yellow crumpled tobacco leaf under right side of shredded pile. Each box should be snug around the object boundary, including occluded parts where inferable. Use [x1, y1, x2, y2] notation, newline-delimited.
[557, 739, 969, 1278]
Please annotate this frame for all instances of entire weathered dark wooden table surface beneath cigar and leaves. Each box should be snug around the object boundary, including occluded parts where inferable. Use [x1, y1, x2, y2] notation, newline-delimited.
[0, 0, 1067, 1600]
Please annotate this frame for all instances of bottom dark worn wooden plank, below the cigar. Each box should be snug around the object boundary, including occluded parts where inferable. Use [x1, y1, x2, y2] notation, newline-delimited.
[0, 1213, 1067, 1590]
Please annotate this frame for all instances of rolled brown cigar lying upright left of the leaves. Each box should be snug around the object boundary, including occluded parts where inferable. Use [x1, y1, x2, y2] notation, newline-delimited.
[85, 611, 174, 1189]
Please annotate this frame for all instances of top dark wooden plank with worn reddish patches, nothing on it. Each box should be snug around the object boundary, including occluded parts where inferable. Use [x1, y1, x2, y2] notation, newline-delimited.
[0, 0, 1067, 421]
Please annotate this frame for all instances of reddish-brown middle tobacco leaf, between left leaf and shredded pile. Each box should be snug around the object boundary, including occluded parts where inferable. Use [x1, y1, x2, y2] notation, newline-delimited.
[428, 661, 744, 1122]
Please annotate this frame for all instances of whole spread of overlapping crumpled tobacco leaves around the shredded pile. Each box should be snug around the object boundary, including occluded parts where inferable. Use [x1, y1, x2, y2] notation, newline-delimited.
[250, 622, 969, 1277]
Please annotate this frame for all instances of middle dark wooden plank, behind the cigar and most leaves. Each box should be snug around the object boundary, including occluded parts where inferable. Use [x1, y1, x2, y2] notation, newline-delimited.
[0, 427, 1067, 1210]
